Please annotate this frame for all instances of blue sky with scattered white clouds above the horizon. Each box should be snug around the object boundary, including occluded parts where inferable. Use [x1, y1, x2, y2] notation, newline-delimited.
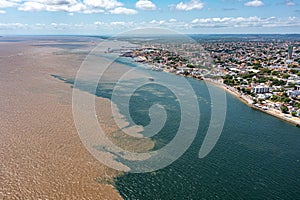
[0, 0, 300, 35]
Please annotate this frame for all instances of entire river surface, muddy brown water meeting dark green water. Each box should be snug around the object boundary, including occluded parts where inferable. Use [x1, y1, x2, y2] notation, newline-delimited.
[0, 36, 300, 200]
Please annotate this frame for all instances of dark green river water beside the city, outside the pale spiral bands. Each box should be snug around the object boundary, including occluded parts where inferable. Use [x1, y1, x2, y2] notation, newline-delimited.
[54, 56, 300, 200]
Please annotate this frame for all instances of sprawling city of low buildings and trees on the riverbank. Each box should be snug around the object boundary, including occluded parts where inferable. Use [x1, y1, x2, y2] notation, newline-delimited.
[122, 36, 300, 126]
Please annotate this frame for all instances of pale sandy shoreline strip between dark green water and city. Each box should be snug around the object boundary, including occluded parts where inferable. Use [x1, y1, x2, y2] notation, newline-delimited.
[203, 78, 300, 127]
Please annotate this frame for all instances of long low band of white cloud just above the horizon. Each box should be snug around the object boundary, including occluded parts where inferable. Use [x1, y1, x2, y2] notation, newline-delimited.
[0, 16, 300, 32]
